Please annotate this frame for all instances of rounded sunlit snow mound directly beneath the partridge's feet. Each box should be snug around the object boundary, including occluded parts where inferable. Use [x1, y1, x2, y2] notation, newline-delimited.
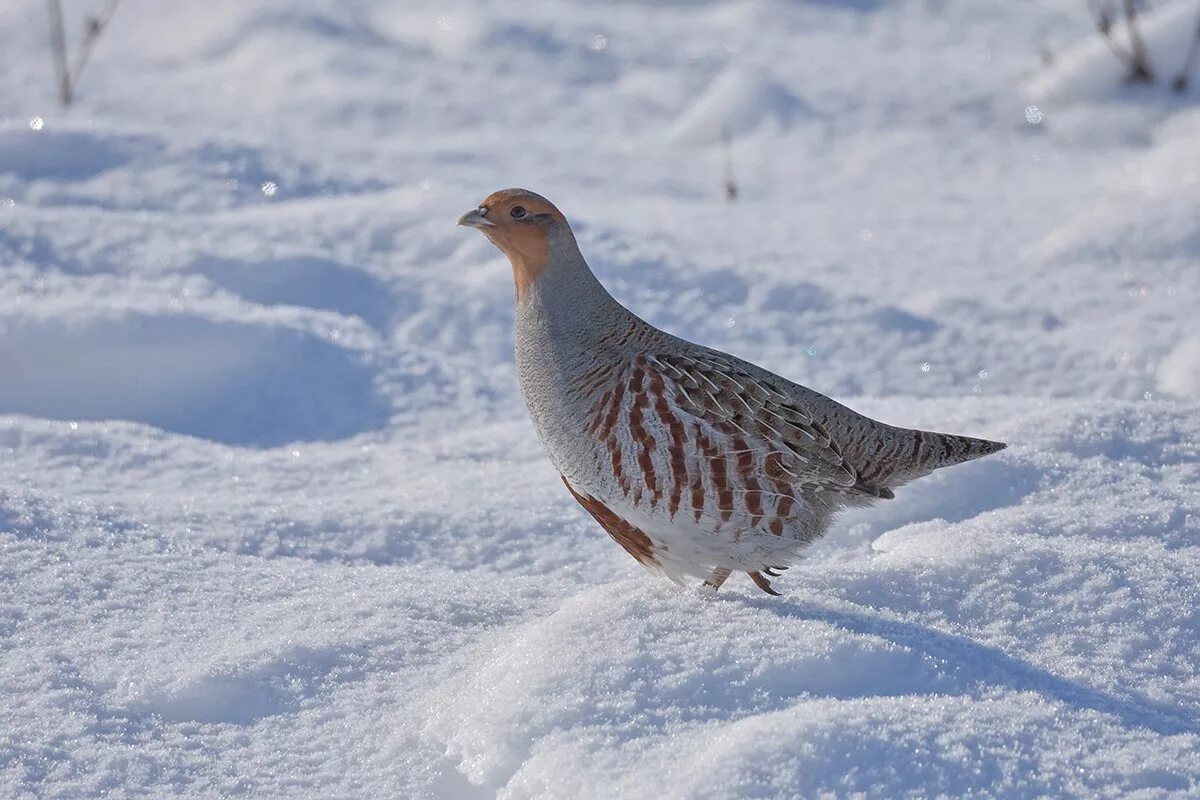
[426, 581, 954, 788]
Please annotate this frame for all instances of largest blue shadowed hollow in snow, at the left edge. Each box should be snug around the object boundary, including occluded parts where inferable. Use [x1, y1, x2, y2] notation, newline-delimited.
[0, 314, 389, 447]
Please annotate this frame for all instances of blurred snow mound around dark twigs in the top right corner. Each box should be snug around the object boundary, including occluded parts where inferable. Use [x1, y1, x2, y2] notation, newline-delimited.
[1028, 0, 1196, 106]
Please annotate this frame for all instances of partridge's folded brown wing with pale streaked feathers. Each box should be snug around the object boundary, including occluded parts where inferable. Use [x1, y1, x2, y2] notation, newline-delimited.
[648, 353, 892, 498]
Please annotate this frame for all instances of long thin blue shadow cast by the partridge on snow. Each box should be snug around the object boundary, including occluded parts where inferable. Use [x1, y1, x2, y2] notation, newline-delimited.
[746, 597, 1200, 735]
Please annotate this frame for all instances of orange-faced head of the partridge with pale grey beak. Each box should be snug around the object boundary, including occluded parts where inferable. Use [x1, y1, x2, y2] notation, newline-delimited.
[458, 188, 577, 296]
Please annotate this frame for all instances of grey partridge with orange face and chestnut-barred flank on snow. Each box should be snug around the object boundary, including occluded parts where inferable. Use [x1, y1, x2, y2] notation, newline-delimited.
[458, 188, 1006, 595]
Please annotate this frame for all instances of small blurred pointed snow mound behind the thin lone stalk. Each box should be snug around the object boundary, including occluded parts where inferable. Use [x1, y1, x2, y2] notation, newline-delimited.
[666, 67, 814, 145]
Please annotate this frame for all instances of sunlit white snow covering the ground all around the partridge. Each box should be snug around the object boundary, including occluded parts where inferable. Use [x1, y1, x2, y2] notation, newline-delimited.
[0, 0, 1200, 799]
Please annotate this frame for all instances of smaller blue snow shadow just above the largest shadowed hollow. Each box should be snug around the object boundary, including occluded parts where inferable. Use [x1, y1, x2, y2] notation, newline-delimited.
[186, 255, 395, 329]
